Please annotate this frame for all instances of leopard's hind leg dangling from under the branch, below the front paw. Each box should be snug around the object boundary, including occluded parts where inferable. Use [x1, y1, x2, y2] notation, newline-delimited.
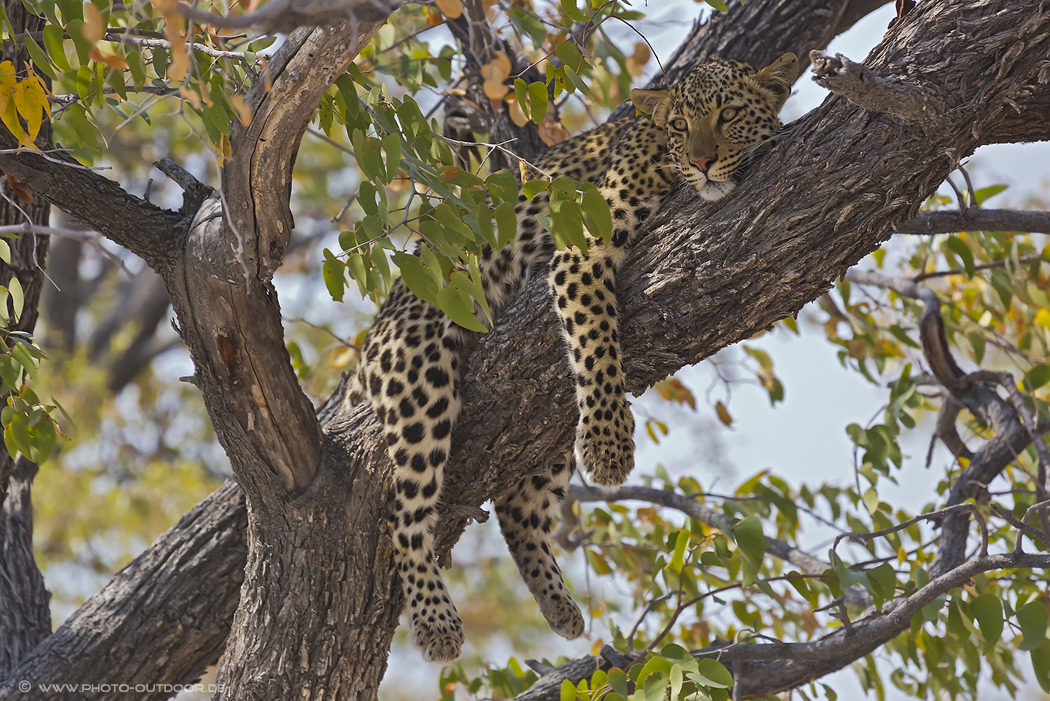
[496, 454, 584, 640]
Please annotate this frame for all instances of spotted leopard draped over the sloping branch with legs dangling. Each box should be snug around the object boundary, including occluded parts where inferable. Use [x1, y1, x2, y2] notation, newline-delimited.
[338, 54, 798, 662]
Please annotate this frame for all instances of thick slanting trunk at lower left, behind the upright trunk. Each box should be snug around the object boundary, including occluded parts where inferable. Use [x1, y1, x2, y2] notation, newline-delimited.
[0, 481, 248, 701]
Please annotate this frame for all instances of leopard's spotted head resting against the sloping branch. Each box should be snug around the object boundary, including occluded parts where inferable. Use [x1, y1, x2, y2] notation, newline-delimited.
[631, 54, 798, 201]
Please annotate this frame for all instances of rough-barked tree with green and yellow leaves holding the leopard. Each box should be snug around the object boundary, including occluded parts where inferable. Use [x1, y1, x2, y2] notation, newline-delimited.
[0, 0, 1050, 699]
